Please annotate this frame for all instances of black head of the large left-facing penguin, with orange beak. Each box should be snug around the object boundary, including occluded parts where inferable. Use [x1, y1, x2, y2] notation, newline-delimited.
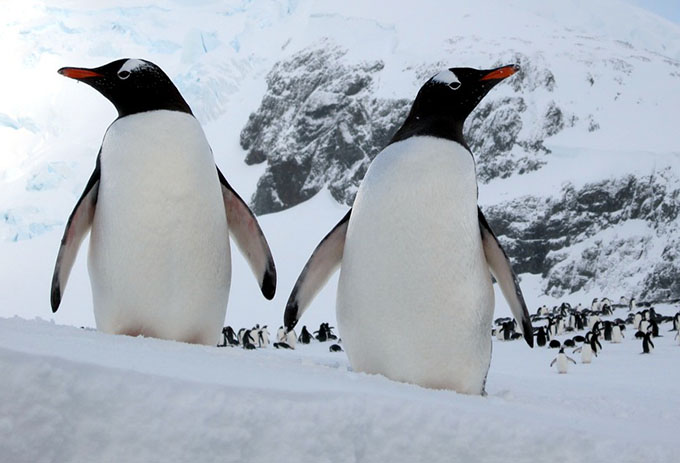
[59, 59, 192, 117]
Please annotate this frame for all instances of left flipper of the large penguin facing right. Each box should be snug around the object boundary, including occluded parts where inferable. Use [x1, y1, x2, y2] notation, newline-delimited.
[283, 209, 352, 333]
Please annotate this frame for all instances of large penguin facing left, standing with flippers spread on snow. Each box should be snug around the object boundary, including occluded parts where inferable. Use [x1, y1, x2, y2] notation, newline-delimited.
[51, 59, 276, 346]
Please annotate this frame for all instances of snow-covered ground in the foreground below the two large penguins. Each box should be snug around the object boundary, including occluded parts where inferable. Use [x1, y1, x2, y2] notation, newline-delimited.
[0, 307, 680, 463]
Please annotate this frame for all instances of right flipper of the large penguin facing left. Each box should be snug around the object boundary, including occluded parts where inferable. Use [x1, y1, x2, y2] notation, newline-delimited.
[217, 168, 276, 299]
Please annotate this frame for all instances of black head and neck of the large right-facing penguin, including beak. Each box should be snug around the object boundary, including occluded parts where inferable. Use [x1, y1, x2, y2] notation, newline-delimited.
[390, 64, 519, 146]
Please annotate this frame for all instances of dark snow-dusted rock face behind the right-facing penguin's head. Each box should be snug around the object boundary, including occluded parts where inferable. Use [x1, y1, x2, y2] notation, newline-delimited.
[241, 41, 570, 214]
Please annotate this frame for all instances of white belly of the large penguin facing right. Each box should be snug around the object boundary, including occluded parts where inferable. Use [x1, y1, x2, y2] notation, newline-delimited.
[337, 137, 494, 394]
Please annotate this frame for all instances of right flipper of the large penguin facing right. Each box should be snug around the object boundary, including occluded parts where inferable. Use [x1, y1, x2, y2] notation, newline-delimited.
[477, 207, 534, 347]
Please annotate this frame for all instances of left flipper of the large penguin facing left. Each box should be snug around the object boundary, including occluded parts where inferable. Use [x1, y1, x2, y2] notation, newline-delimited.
[50, 158, 101, 312]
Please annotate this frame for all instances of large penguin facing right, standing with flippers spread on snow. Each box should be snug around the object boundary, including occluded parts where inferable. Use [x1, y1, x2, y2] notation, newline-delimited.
[284, 65, 533, 394]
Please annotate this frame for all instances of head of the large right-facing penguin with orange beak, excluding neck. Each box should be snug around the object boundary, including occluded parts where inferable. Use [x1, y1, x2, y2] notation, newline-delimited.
[411, 64, 519, 123]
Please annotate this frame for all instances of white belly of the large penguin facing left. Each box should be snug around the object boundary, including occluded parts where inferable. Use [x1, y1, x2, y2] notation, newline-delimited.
[88, 111, 231, 345]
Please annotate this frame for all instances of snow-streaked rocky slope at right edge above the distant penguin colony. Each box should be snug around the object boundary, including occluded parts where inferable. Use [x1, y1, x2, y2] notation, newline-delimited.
[484, 169, 680, 300]
